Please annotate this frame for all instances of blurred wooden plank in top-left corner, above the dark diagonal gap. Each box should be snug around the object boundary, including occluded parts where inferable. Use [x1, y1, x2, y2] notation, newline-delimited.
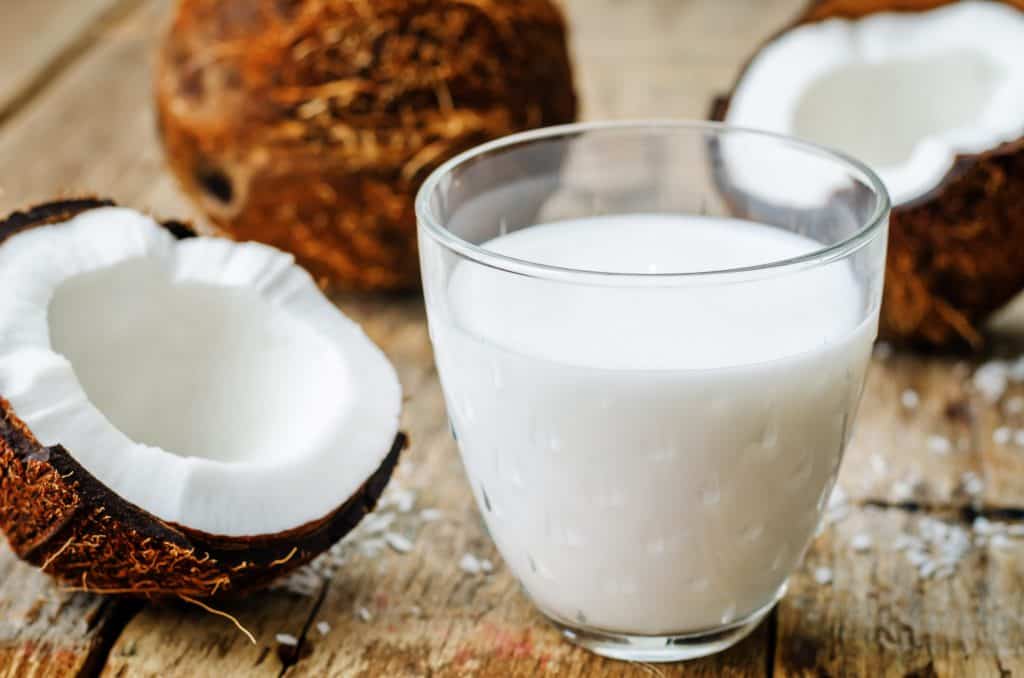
[0, 0, 134, 120]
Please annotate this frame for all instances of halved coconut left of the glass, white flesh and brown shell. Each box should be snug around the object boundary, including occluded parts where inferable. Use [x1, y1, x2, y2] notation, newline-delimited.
[0, 200, 406, 598]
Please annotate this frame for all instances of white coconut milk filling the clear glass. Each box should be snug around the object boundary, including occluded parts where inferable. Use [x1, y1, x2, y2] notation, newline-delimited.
[431, 215, 877, 635]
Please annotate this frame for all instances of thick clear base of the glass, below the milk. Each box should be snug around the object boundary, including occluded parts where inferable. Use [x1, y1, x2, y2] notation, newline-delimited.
[548, 587, 785, 663]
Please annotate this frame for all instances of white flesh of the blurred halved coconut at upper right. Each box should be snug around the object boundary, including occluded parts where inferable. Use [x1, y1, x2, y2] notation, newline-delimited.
[726, 1, 1024, 204]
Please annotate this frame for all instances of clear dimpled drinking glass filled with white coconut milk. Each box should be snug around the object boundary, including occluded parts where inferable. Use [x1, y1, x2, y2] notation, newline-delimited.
[417, 122, 889, 662]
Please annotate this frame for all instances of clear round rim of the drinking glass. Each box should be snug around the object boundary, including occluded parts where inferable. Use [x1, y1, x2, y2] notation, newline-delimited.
[416, 119, 892, 286]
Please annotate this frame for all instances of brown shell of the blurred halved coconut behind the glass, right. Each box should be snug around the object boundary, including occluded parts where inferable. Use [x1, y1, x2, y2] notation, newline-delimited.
[711, 0, 1024, 349]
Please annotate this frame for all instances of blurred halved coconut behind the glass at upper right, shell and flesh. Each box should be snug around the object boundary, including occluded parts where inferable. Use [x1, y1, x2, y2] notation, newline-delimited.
[712, 0, 1024, 348]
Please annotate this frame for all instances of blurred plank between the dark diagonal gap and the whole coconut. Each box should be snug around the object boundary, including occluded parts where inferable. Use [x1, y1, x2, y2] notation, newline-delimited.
[0, 0, 196, 223]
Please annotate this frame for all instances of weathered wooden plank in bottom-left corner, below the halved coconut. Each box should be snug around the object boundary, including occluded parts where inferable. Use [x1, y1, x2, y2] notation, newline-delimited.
[0, 543, 124, 678]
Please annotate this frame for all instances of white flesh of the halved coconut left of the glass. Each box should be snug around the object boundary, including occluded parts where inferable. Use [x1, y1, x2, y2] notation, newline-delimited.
[0, 208, 401, 537]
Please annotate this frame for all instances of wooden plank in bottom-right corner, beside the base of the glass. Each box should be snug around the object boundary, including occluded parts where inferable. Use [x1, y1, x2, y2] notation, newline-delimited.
[774, 508, 1024, 677]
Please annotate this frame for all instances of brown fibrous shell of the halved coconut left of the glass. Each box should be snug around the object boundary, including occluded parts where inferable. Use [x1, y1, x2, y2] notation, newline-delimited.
[0, 199, 407, 598]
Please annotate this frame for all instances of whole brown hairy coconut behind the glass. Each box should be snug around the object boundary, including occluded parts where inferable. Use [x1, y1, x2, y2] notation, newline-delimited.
[156, 0, 577, 290]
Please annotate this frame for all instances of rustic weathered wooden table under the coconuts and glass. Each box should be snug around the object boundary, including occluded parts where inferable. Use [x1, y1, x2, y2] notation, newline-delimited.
[0, 0, 1024, 677]
